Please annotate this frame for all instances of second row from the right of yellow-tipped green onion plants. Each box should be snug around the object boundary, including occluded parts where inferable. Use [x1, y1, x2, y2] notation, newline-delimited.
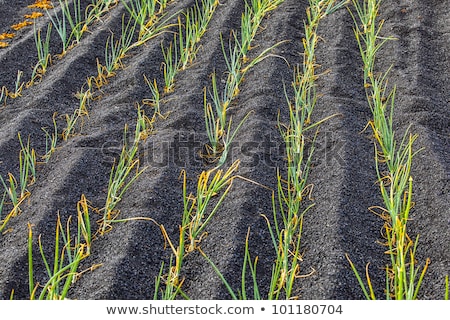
[204, 0, 345, 300]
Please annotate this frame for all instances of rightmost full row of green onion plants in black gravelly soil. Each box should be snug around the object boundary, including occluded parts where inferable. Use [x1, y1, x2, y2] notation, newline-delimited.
[347, 0, 429, 300]
